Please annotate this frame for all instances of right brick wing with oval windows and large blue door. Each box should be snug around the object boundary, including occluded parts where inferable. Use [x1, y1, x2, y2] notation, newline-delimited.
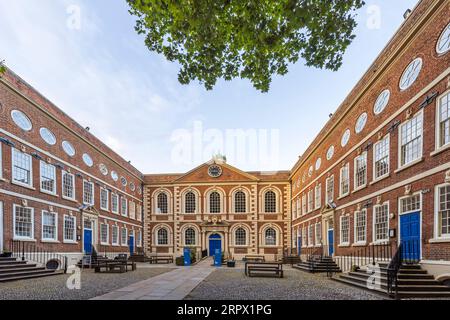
[291, 0, 450, 276]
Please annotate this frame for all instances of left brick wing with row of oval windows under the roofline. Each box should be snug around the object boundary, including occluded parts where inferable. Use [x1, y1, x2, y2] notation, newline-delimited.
[0, 70, 143, 263]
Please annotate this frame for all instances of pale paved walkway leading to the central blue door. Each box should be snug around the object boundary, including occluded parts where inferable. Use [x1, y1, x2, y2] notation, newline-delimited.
[92, 259, 214, 300]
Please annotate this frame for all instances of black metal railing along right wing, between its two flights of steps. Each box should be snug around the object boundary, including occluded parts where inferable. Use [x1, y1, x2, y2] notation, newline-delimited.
[334, 242, 395, 272]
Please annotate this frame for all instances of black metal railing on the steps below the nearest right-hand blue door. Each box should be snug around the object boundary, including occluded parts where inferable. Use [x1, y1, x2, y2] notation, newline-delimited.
[387, 240, 420, 299]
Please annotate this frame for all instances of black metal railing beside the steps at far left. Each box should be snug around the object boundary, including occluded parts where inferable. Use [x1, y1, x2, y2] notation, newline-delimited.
[10, 240, 68, 273]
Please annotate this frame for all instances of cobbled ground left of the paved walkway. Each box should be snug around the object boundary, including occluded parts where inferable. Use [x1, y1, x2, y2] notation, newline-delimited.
[0, 268, 173, 300]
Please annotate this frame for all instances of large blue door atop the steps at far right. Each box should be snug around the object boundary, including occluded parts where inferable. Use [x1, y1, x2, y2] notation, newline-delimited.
[400, 212, 420, 261]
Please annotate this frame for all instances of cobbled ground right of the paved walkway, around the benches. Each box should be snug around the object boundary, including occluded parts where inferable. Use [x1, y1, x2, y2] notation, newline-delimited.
[185, 268, 383, 300]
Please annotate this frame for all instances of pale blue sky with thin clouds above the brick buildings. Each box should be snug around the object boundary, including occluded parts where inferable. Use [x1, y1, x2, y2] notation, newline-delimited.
[0, 0, 418, 173]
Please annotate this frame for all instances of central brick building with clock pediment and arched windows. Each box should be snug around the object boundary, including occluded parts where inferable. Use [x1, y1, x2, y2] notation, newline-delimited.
[144, 157, 291, 259]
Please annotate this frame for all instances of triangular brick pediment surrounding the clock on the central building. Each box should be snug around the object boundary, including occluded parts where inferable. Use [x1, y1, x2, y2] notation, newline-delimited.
[174, 160, 259, 183]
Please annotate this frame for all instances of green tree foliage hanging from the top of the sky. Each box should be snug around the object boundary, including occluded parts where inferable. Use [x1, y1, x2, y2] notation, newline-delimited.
[127, 0, 364, 92]
